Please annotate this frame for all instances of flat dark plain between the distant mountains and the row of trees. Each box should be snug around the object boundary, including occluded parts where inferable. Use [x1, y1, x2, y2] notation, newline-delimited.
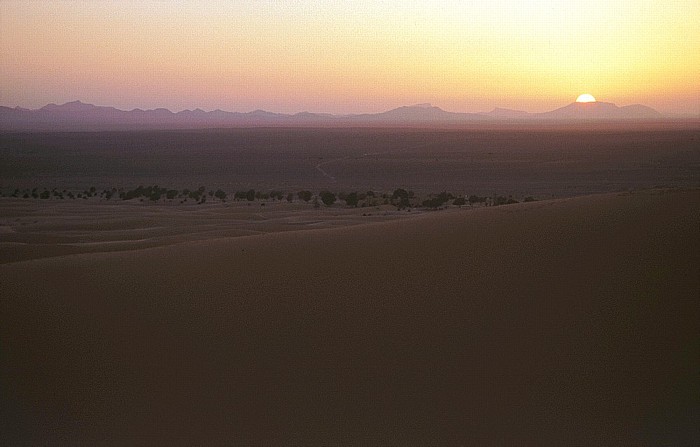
[0, 128, 700, 199]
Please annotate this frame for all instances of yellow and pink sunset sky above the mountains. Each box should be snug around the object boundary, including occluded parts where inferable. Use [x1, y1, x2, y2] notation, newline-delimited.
[0, 0, 700, 116]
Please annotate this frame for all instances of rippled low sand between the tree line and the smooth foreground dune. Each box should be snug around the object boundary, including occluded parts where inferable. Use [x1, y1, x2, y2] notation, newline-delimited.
[0, 198, 420, 264]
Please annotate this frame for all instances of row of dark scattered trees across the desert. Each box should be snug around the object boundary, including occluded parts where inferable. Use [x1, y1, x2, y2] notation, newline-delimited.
[0, 185, 534, 210]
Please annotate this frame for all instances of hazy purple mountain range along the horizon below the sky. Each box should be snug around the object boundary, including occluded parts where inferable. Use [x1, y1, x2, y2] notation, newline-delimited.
[0, 101, 662, 131]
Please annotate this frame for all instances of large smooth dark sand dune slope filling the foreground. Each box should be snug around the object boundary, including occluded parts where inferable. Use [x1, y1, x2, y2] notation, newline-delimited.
[0, 190, 700, 445]
